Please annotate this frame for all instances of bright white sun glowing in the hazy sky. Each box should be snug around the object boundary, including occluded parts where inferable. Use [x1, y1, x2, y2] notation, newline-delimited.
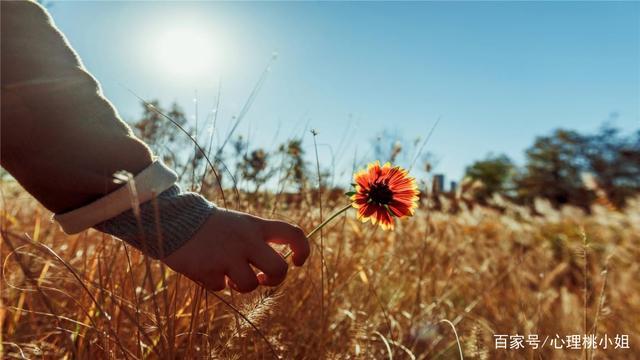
[152, 24, 222, 79]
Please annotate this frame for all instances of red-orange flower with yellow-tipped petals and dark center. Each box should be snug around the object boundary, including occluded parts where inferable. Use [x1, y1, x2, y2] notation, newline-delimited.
[349, 161, 419, 230]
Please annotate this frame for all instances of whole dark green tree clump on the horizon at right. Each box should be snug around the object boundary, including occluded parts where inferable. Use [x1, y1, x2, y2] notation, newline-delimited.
[465, 125, 640, 209]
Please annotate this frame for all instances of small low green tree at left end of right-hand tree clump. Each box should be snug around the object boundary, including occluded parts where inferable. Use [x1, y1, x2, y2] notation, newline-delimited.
[465, 154, 516, 203]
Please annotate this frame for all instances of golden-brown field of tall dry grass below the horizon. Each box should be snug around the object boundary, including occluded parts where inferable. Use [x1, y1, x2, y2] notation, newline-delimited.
[0, 182, 640, 359]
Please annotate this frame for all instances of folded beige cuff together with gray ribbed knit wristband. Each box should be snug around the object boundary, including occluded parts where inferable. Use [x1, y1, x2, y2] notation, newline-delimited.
[53, 161, 216, 259]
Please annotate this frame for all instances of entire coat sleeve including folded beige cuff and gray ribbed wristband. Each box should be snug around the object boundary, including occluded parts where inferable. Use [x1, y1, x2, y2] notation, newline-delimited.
[0, 1, 216, 258]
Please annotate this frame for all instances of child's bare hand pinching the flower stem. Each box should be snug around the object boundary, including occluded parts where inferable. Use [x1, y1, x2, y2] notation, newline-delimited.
[163, 210, 309, 292]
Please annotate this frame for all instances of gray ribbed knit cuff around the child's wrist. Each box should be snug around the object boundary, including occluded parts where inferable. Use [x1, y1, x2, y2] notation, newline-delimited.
[94, 185, 216, 259]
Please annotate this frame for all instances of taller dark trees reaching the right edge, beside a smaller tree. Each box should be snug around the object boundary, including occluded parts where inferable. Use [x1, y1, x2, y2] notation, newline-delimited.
[516, 125, 640, 209]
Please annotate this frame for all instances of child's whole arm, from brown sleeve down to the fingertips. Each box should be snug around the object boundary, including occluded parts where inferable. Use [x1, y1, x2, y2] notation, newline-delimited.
[0, 1, 309, 292]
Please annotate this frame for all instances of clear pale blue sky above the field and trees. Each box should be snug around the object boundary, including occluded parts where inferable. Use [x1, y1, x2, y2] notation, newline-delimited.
[49, 2, 640, 186]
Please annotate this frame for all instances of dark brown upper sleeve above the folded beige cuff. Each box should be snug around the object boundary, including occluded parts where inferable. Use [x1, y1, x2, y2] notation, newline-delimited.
[0, 1, 152, 213]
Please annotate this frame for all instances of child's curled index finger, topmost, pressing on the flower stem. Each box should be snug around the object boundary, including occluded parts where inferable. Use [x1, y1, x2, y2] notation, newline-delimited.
[263, 220, 310, 266]
